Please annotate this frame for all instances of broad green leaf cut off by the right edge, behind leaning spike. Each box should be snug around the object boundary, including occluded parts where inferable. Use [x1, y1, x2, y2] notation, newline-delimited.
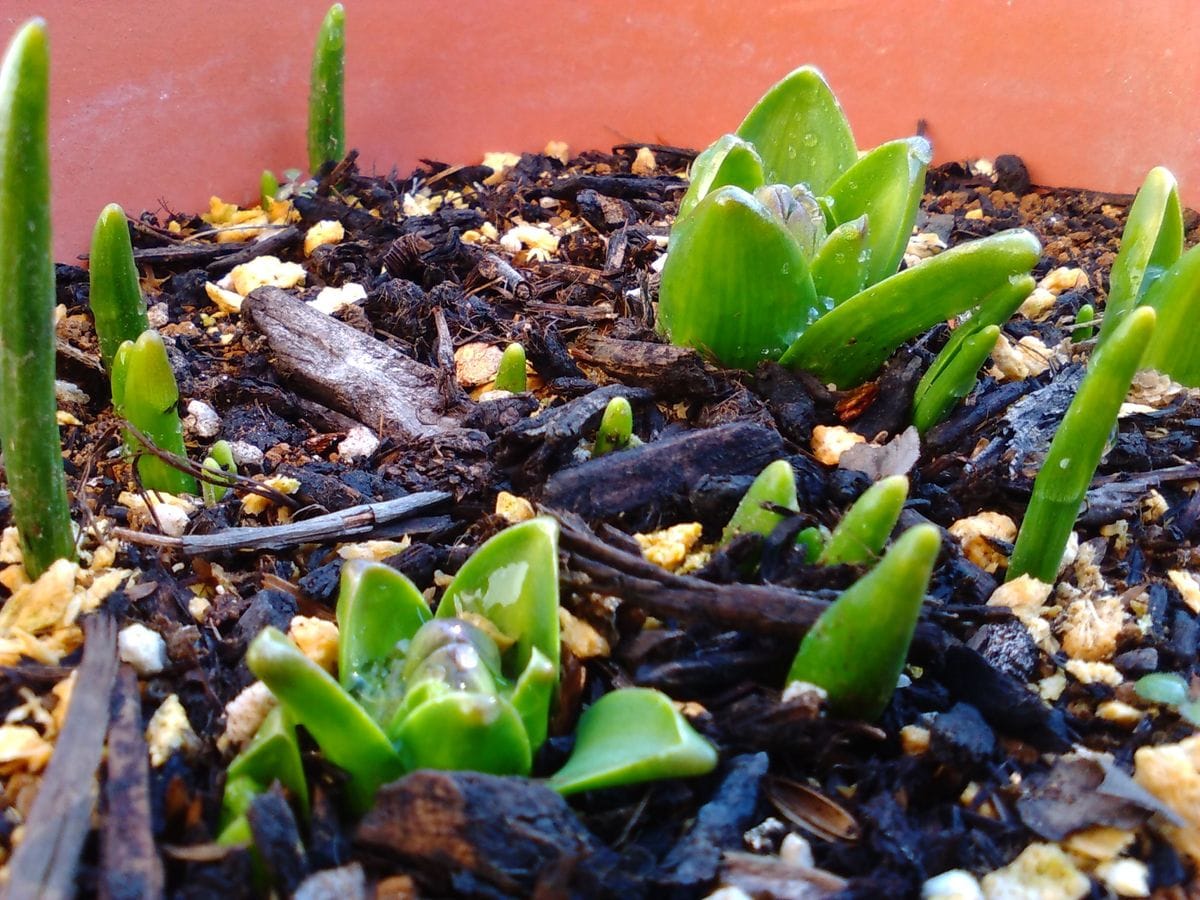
[1137, 247, 1200, 388]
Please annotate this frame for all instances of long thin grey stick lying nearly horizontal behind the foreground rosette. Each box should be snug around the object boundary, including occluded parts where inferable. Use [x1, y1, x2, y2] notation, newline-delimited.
[113, 491, 450, 556]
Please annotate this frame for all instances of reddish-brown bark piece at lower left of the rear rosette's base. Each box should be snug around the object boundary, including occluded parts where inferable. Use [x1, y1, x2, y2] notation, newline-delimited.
[571, 335, 722, 400]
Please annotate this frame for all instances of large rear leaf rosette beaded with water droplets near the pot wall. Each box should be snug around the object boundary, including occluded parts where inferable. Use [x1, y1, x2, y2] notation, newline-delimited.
[659, 67, 1040, 388]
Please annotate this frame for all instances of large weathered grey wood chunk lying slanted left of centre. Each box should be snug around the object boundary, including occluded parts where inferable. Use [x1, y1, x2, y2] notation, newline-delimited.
[241, 287, 466, 438]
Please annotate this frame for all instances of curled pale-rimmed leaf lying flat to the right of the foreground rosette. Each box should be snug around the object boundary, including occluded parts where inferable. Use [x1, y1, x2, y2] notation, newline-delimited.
[550, 688, 716, 794]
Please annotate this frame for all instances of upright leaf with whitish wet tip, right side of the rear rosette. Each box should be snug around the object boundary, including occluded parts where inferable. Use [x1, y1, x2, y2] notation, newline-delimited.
[829, 138, 934, 284]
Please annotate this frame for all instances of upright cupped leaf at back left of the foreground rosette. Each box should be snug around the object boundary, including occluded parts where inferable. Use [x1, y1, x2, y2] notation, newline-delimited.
[337, 559, 433, 718]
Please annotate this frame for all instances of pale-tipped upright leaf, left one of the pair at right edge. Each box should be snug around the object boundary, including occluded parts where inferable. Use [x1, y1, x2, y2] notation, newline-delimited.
[1100, 166, 1183, 342]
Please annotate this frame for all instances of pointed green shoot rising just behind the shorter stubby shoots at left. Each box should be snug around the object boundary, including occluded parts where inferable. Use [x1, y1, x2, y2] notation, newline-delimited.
[88, 203, 150, 372]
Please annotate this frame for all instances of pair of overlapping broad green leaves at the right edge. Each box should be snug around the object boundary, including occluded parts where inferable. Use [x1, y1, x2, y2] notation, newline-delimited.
[1099, 167, 1200, 388]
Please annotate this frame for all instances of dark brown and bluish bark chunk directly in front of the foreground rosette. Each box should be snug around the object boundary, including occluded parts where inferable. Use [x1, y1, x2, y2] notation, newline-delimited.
[355, 770, 624, 896]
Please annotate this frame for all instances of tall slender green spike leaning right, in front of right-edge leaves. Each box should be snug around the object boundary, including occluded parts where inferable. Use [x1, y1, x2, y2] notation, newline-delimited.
[1007, 306, 1154, 583]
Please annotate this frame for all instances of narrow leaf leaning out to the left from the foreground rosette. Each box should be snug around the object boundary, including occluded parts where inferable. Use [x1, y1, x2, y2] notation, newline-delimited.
[246, 626, 404, 814]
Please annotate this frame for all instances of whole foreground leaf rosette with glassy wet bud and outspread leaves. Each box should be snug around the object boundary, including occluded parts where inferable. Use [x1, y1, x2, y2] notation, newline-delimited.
[221, 517, 716, 841]
